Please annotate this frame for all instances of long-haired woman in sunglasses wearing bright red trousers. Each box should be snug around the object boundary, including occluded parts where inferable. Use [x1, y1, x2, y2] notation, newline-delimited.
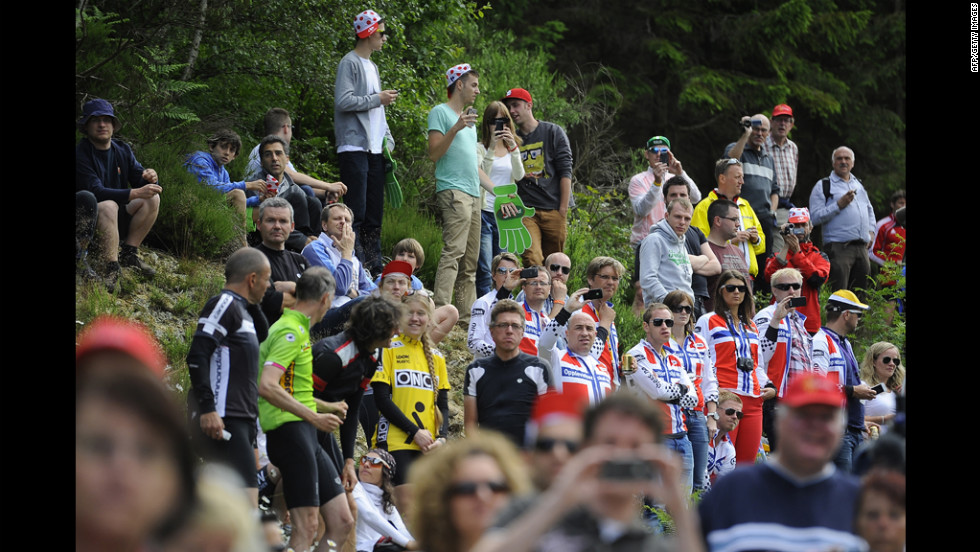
[695, 270, 776, 465]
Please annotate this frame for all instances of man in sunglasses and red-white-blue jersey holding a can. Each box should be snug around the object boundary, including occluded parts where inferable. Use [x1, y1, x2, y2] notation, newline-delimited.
[626, 303, 698, 492]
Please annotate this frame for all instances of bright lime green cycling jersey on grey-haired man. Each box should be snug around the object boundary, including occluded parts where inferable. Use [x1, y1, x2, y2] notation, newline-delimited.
[259, 309, 316, 431]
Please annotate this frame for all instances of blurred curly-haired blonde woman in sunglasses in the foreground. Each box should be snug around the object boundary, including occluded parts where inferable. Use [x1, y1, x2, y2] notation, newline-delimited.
[410, 429, 531, 552]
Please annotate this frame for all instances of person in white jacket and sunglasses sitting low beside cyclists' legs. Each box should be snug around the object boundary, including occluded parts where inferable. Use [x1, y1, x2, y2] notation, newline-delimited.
[353, 449, 417, 552]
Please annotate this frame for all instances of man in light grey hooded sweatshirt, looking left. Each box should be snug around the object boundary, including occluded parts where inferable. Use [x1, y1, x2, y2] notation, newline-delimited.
[640, 198, 694, 305]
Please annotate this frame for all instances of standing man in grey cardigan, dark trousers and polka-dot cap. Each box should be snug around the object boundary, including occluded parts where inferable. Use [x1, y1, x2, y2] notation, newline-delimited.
[334, 10, 398, 274]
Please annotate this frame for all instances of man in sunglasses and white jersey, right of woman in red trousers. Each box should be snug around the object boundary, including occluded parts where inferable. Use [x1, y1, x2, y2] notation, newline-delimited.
[752, 268, 815, 451]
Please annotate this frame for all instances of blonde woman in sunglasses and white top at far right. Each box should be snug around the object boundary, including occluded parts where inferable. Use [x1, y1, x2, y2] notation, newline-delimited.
[861, 341, 905, 433]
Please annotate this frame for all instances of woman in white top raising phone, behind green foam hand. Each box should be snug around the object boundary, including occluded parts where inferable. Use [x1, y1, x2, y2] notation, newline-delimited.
[476, 101, 524, 297]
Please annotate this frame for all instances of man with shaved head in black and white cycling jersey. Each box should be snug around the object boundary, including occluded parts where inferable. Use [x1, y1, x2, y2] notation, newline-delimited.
[187, 247, 272, 507]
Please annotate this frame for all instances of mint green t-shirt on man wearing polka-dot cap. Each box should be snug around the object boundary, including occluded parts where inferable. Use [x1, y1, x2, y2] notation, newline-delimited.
[429, 104, 480, 197]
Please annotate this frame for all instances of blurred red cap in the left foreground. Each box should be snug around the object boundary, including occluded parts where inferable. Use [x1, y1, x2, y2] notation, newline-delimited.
[75, 315, 167, 377]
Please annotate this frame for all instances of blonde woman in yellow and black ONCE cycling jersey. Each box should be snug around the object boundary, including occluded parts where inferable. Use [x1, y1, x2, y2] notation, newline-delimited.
[371, 290, 449, 511]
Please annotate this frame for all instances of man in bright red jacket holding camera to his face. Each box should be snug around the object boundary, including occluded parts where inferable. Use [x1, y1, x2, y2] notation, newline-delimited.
[764, 207, 830, 335]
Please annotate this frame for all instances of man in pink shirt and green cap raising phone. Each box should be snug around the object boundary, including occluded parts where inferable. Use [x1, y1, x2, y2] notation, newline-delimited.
[629, 136, 701, 247]
